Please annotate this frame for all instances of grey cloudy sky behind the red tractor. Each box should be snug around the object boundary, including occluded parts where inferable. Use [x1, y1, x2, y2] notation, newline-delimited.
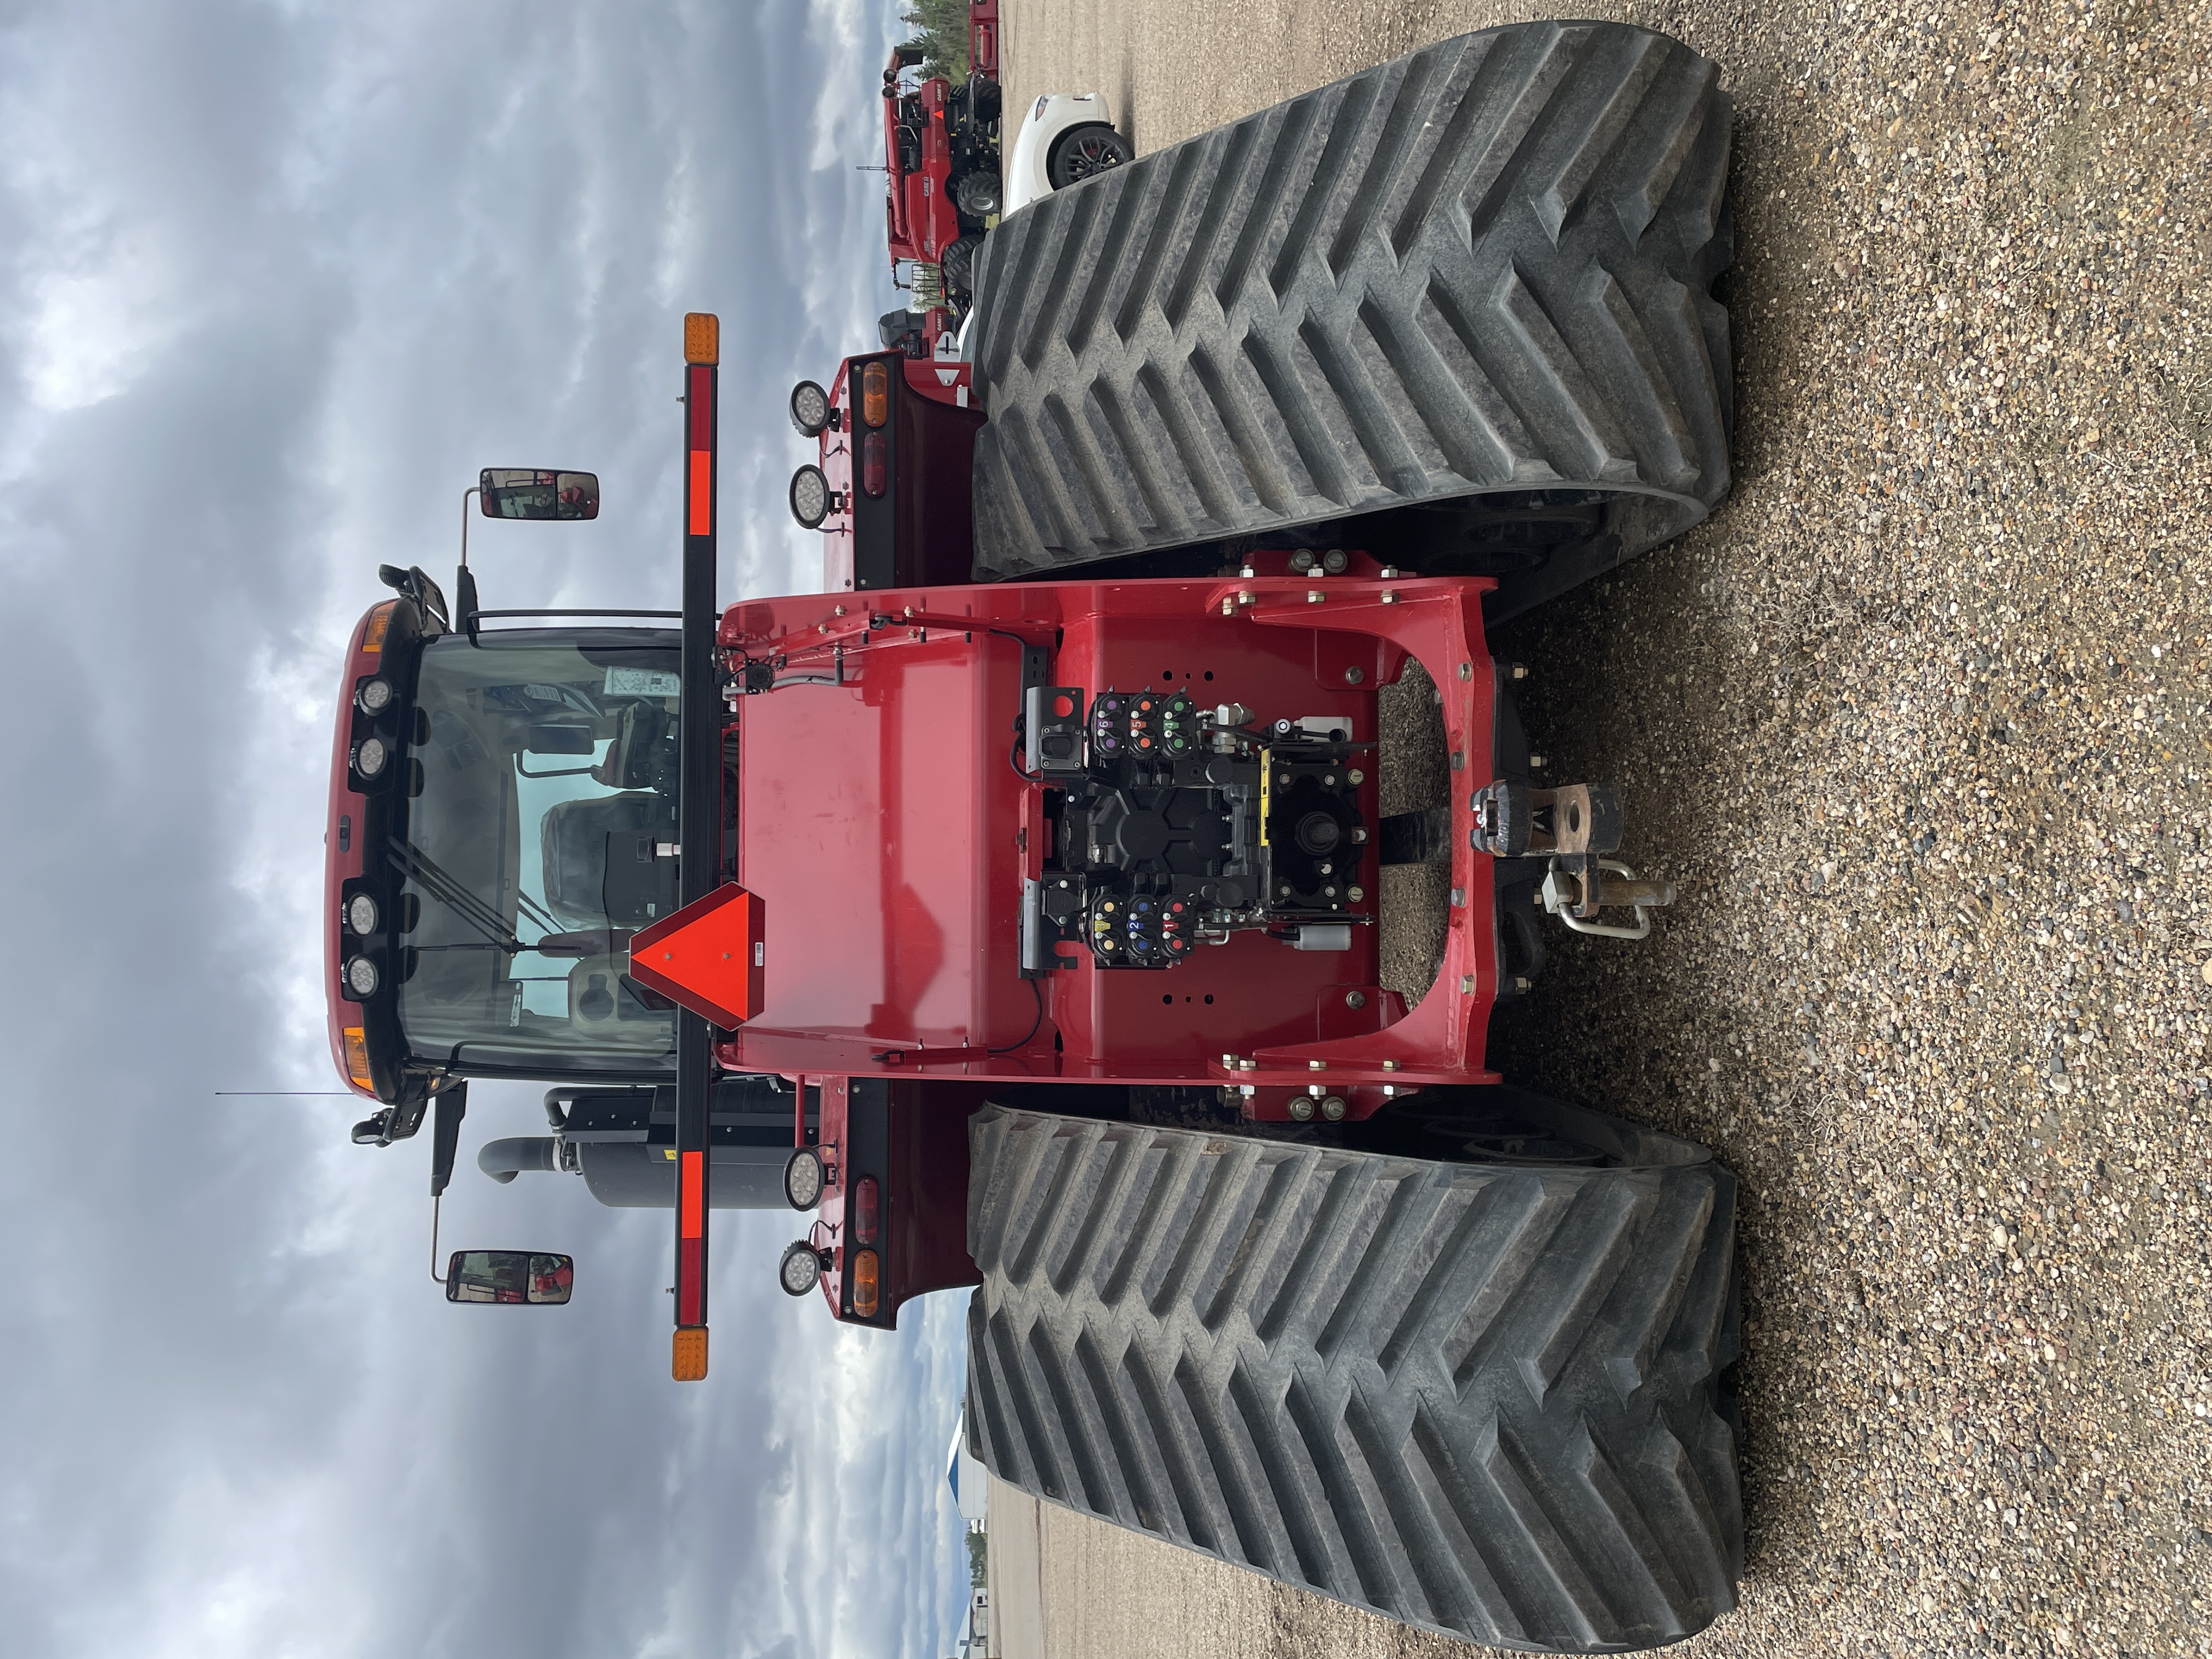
[0, 0, 964, 1659]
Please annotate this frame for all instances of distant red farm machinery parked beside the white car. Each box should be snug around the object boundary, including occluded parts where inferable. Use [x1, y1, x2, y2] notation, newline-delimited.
[878, 0, 1005, 356]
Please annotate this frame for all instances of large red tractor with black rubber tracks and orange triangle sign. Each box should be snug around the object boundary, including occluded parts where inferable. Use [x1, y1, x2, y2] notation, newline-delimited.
[325, 24, 1743, 1650]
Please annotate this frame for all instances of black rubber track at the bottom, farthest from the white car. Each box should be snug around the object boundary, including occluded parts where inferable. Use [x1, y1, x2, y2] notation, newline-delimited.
[967, 1108, 1743, 1652]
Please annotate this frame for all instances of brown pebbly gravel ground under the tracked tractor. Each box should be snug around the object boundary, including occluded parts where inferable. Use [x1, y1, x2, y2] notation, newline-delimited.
[1005, 0, 2212, 1657]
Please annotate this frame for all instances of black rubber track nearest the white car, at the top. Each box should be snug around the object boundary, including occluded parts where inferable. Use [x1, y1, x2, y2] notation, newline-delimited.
[975, 22, 1732, 575]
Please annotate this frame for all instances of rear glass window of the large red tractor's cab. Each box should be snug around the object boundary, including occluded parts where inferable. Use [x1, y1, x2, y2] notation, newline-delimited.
[385, 628, 679, 1075]
